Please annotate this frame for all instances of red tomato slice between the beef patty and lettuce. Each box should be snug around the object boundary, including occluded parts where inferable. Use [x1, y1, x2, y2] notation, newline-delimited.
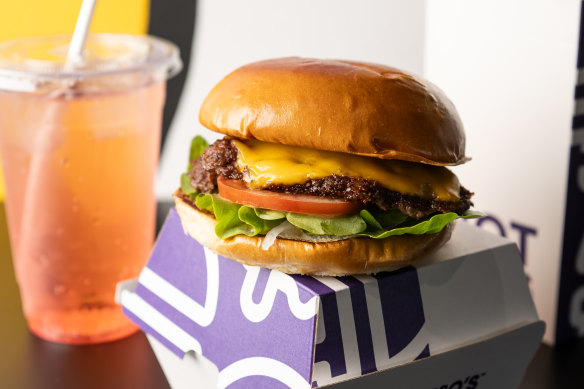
[217, 177, 363, 216]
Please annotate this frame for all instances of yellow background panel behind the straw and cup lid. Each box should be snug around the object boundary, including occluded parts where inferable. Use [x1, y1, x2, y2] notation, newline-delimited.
[0, 0, 150, 201]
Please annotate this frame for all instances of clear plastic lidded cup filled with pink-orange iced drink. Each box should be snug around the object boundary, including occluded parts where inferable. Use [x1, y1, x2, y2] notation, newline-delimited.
[0, 34, 181, 344]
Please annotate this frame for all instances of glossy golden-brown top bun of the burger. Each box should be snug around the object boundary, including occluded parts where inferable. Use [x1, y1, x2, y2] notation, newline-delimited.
[199, 58, 468, 166]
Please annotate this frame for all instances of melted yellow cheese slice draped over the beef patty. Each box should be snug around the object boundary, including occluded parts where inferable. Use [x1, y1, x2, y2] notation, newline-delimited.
[232, 139, 460, 201]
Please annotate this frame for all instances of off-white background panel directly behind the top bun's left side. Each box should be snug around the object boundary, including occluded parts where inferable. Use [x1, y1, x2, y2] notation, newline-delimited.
[156, 0, 424, 199]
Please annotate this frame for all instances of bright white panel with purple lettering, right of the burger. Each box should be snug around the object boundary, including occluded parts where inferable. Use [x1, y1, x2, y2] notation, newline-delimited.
[424, 0, 581, 342]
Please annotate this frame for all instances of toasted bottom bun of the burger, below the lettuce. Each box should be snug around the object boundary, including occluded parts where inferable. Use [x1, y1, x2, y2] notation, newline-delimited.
[174, 191, 454, 276]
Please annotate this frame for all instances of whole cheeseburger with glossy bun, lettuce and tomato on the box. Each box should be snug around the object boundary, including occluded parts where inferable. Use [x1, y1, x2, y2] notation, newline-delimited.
[174, 58, 477, 275]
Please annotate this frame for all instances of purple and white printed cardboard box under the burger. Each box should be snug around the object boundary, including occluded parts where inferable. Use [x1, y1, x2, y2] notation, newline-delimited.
[117, 210, 544, 389]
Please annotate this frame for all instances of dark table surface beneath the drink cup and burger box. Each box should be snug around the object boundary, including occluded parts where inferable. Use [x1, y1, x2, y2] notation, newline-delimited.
[0, 204, 584, 389]
